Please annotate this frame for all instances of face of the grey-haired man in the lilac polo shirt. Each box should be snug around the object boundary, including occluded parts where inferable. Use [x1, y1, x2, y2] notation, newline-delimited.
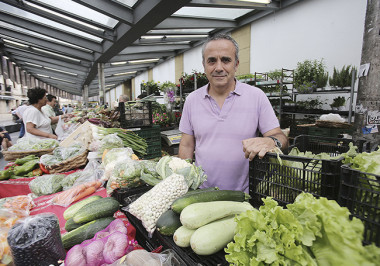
[203, 40, 239, 88]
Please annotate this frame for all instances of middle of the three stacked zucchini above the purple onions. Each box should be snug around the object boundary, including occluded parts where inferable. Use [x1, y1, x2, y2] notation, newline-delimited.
[73, 197, 119, 224]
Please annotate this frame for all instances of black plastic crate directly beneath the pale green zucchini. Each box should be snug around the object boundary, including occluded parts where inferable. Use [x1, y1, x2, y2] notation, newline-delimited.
[155, 231, 229, 266]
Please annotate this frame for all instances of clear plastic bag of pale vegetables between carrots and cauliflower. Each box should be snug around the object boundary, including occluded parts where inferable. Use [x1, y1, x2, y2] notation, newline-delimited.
[107, 159, 144, 194]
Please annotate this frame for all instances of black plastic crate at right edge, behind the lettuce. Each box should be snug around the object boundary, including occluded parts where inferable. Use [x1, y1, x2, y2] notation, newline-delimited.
[338, 165, 380, 246]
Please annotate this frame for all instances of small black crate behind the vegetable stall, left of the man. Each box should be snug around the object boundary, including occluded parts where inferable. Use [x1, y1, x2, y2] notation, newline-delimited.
[119, 102, 153, 128]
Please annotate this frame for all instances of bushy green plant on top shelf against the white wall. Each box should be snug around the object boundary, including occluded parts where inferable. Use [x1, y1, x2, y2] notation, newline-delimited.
[294, 59, 328, 90]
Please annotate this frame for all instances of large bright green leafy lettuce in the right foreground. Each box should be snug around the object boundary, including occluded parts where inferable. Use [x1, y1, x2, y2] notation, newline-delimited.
[225, 193, 380, 265]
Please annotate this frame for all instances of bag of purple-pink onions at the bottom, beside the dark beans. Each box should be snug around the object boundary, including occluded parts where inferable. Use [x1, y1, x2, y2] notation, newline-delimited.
[65, 219, 137, 266]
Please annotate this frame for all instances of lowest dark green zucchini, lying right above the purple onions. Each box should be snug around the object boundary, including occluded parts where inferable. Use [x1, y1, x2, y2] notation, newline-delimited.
[62, 217, 115, 249]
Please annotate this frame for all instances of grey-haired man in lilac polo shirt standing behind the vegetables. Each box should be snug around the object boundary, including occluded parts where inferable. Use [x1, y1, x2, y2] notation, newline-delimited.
[179, 35, 288, 192]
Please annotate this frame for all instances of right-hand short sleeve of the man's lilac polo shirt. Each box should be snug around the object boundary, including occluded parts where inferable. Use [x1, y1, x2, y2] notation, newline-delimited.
[259, 93, 280, 134]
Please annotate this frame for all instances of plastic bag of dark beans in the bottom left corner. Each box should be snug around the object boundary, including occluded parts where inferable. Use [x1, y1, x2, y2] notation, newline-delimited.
[7, 213, 66, 266]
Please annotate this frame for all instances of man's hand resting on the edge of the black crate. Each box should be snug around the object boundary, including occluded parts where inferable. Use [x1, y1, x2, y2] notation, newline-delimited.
[243, 137, 276, 161]
